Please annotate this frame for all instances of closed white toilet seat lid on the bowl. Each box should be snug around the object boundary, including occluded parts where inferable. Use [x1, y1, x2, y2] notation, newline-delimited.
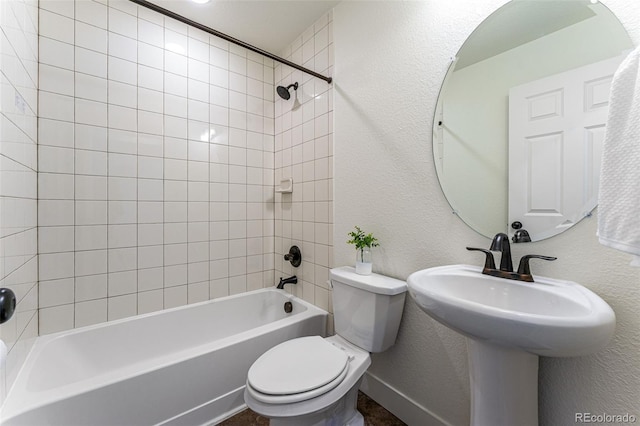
[247, 336, 349, 396]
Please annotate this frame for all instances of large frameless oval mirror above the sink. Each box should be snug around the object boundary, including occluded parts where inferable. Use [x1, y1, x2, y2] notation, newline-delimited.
[433, 0, 633, 242]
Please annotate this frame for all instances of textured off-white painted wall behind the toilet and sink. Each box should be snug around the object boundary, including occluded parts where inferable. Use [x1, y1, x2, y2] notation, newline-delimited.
[334, 0, 640, 425]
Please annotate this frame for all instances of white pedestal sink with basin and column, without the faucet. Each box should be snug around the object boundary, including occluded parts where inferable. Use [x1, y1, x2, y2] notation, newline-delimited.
[407, 265, 616, 426]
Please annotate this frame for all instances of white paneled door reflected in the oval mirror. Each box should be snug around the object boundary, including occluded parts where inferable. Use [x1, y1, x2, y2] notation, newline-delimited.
[508, 57, 622, 239]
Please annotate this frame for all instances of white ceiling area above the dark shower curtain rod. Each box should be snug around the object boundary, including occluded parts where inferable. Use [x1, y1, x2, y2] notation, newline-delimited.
[150, 0, 340, 55]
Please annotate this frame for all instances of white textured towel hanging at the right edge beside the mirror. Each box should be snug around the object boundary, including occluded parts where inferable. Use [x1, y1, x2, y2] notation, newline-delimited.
[598, 47, 640, 266]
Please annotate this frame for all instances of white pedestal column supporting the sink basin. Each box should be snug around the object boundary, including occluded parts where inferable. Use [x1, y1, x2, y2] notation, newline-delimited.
[467, 338, 538, 426]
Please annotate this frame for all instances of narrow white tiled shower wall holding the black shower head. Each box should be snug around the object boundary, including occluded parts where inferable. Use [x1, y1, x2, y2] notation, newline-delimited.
[275, 12, 333, 323]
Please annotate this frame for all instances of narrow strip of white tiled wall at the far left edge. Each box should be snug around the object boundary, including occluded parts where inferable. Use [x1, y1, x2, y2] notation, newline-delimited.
[0, 0, 38, 396]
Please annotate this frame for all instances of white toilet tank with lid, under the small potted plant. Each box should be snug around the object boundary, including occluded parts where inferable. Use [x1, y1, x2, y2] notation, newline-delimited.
[330, 266, 407, 352]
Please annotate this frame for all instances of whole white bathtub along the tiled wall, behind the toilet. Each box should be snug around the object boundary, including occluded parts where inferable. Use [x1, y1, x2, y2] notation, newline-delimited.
[0, 289, 327, 426]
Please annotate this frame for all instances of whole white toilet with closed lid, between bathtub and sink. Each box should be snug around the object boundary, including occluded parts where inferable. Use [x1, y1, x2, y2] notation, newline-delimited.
[244, 267, 407, 426]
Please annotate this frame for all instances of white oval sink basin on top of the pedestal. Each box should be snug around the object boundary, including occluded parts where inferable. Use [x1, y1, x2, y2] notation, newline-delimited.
[407, 265, 615, 357]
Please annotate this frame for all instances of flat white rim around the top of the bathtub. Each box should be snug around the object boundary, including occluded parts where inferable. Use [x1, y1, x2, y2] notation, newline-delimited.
[0, 287, 328, 423]
